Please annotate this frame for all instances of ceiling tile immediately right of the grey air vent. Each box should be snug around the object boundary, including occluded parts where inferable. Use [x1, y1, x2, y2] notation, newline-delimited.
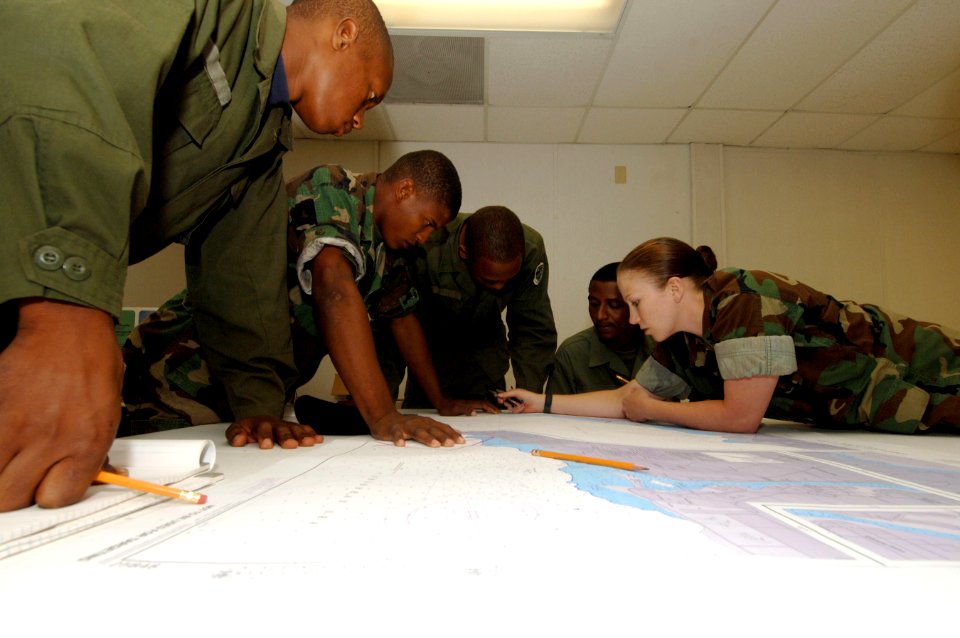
[487, 34, 613, 107]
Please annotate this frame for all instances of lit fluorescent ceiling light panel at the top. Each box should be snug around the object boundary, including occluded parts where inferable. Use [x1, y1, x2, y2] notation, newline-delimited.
[375, 0, 626, 33]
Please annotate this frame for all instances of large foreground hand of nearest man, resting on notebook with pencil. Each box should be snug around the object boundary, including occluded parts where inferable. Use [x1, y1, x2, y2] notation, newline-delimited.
[0, 299, 123, 512]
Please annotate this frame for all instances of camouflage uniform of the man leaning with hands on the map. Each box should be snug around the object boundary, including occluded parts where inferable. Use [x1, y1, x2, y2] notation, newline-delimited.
[123, 166, 418, 433]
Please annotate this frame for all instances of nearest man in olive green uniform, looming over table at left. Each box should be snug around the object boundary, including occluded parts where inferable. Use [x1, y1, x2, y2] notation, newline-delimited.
[0, 0, 393, 511]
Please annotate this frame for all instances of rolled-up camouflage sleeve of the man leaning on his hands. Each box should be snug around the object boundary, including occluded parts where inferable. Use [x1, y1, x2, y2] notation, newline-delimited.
[288, 166, 366, 294]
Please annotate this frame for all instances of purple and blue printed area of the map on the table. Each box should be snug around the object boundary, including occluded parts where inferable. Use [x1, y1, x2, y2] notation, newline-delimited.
[471, 426, 960, 565]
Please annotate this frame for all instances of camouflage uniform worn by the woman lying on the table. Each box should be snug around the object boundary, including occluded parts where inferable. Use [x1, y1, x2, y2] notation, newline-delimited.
[637, 268, 960, 433]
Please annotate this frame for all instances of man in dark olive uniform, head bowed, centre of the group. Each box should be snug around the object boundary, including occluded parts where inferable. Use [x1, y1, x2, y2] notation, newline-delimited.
[377, 206, 557, 408]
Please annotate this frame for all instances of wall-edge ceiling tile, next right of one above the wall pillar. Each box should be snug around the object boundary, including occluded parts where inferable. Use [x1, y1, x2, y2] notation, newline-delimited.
[752, 113, 879, 148]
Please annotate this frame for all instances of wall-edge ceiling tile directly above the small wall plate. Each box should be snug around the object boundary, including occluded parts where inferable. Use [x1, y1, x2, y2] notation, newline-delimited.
[577, 108, 687, 144]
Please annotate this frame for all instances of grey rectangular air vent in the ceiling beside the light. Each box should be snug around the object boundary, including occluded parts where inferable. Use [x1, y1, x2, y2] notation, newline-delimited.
[385, 35, 483, 104]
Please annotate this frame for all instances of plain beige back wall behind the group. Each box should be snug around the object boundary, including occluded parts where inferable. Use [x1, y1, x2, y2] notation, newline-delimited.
[126, 140, 960, 396]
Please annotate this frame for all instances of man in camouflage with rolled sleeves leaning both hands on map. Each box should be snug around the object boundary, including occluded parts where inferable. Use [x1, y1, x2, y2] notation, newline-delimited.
[121, 151, 492, 442]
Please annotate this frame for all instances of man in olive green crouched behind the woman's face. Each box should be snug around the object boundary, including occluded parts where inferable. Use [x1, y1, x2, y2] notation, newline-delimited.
[547, 262, 656, 394]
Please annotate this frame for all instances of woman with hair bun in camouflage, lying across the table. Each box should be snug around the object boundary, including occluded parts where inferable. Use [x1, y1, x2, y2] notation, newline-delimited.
[502, 238, 960, 433]
